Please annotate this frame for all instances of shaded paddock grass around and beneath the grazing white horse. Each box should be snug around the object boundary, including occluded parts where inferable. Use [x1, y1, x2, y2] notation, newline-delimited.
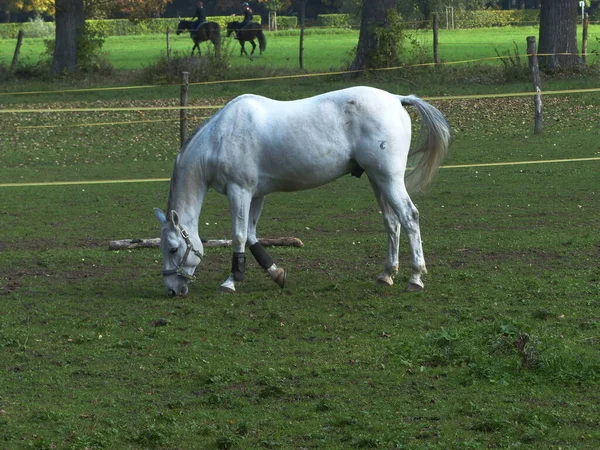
[0, 27, 600, 450]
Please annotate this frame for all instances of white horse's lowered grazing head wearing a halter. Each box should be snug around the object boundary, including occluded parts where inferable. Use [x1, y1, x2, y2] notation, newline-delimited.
[154, 208, 204, 296]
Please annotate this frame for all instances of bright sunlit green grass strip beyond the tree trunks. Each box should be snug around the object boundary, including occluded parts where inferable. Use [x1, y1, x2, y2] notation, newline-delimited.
[0, 25, 600, 71]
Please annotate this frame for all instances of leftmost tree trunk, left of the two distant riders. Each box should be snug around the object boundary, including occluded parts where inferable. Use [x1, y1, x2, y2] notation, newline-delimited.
[50, 0, 85, 74]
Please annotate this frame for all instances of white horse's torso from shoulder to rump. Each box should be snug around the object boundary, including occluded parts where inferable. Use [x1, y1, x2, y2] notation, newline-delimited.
[194, 87, 410, 194]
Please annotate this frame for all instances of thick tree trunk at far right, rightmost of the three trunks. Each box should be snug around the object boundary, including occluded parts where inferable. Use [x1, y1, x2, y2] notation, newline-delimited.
[538, 0, 580, 69]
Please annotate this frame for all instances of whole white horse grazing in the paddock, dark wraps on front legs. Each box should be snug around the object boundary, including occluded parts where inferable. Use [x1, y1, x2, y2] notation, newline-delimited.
[154, 87, 451, 296]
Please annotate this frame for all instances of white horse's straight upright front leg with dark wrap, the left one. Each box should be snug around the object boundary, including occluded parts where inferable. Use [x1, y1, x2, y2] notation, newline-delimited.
[220, 185, 252, 293]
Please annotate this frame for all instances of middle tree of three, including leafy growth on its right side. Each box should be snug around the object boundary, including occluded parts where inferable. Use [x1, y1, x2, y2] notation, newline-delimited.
[350, 0, 401, 70]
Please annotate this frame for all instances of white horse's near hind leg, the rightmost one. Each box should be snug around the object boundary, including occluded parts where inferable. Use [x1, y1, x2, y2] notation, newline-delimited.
[375, 177, 427, 291]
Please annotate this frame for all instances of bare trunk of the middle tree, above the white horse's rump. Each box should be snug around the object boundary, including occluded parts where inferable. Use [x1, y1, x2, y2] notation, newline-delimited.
[350, 0, 397, 70]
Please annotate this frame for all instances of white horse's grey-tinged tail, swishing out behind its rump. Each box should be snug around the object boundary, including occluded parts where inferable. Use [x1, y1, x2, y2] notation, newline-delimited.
[400, 95, 452, 191]
